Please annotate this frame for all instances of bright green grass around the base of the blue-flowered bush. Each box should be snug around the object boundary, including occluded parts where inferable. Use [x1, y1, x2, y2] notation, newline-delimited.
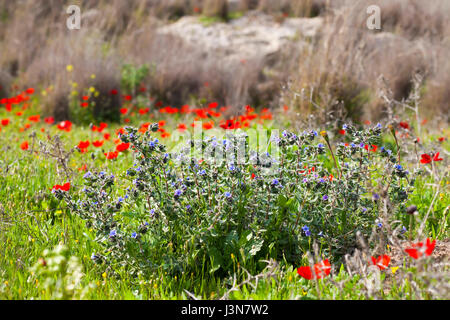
[0, 100, 450, 300]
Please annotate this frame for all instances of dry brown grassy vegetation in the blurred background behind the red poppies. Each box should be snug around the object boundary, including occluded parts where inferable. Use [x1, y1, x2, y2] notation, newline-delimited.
[0, 0, 450, 120]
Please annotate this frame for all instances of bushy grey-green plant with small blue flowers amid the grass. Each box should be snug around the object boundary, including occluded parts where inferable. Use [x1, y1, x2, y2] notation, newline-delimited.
[58, 124, 414, 275]
